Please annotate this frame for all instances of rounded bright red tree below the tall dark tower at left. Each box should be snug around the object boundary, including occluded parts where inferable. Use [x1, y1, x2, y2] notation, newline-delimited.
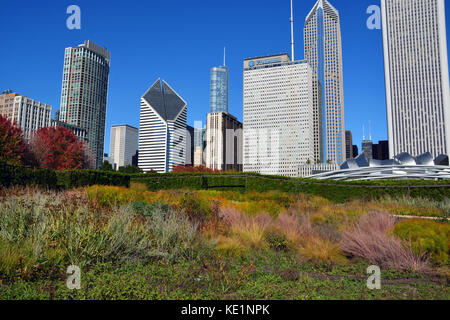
[31, 127, 90, 170]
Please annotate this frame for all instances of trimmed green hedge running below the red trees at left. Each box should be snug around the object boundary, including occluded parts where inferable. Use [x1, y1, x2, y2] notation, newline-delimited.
[0, 165, 130, 189]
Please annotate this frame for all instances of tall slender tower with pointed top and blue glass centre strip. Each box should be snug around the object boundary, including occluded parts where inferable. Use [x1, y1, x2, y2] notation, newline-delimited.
[304, 0, 345, 164]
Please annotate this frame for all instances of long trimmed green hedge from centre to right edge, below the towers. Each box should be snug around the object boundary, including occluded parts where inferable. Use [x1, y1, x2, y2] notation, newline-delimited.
[131, 173, 450, 202]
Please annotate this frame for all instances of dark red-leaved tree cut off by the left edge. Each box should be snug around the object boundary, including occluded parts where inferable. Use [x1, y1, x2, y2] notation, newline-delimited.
[0, 115, 27, 165]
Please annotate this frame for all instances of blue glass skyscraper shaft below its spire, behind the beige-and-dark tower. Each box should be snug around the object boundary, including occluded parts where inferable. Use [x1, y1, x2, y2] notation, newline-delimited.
[210, 66, 228, 113]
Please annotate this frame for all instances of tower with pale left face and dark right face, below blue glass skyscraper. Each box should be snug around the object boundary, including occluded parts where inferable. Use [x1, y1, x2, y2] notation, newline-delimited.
[206, 112, 242, 171]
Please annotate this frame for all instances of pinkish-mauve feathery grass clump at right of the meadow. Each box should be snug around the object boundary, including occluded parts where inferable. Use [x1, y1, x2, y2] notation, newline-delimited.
[342, 212, 429, 272]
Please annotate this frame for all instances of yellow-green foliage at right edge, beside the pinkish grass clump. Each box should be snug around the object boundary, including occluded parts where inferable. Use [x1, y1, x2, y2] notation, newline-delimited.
[393, 219, 450, 264]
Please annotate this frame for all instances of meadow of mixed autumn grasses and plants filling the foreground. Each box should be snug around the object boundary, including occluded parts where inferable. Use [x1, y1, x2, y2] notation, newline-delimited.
[0, 183, 450, 299]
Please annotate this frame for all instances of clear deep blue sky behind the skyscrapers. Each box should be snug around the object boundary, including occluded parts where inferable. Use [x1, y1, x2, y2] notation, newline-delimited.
[0, 0, 450, 153]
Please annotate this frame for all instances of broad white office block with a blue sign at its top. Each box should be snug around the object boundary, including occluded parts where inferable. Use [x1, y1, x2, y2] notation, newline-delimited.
[243, 54, 314, 177]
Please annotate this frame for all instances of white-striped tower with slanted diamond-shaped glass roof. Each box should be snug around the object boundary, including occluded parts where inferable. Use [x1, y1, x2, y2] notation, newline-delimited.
[138, 79, 187, 173]
